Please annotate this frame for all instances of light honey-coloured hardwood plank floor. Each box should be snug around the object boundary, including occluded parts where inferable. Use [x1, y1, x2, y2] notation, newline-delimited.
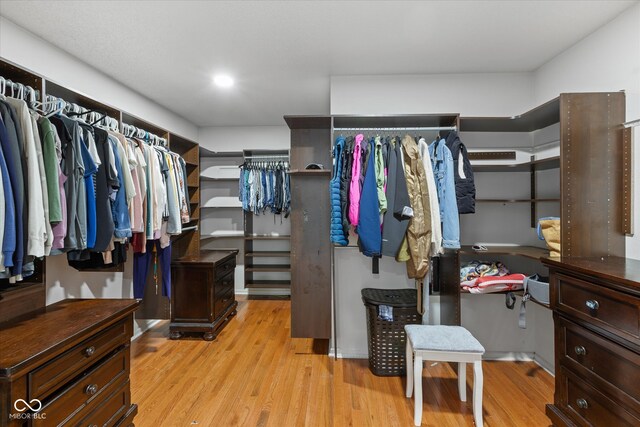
[131, 300, 553, 427]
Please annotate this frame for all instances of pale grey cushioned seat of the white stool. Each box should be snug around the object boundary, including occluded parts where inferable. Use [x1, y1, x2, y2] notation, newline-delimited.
[404, 325, 484, 353]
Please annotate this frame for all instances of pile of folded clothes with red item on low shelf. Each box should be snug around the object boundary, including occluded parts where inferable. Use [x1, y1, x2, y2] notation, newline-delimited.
[460, 261, 526, 294]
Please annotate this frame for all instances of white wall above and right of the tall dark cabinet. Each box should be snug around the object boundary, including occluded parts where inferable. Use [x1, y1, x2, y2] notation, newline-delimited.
[534, 4, 640, 259]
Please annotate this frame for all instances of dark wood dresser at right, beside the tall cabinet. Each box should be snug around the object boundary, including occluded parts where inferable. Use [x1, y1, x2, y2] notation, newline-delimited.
[542, 257, 640, 427]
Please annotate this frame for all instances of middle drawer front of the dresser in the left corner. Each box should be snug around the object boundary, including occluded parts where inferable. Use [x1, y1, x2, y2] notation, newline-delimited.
[34, 348, 129, 427]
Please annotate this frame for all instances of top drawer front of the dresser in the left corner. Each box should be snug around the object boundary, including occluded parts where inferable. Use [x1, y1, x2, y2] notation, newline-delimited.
[29, 319, 131, 400]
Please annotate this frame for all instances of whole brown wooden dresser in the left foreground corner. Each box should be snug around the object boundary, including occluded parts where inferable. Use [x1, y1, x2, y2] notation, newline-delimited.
[0, 299, 138, 427]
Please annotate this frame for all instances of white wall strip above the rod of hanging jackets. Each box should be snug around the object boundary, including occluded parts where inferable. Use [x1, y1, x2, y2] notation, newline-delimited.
[331, 73, 533, 116]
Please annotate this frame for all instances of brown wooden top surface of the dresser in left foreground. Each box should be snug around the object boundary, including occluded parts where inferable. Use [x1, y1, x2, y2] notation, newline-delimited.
[0, 299, 139, 380]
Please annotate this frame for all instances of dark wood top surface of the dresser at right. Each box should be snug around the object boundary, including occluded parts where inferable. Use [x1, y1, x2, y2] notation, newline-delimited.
[541, 257, 640, 291]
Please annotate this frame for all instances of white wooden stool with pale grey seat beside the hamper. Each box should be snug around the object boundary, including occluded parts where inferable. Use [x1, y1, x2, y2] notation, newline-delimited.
[404, 325, 484, 427]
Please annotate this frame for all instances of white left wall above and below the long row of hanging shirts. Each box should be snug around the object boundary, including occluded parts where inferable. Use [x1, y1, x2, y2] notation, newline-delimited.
[0, 17, 198, 335]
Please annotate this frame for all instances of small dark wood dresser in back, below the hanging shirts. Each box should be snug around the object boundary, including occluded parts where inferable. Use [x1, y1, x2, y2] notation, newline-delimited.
[169, 250, 238, 341]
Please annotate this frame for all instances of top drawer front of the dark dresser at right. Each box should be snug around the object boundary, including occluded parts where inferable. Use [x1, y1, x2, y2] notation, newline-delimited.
[557, 274, 640, 343]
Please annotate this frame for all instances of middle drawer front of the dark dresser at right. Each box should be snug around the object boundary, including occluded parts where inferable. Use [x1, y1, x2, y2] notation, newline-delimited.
[559, 319, 640, 405]
